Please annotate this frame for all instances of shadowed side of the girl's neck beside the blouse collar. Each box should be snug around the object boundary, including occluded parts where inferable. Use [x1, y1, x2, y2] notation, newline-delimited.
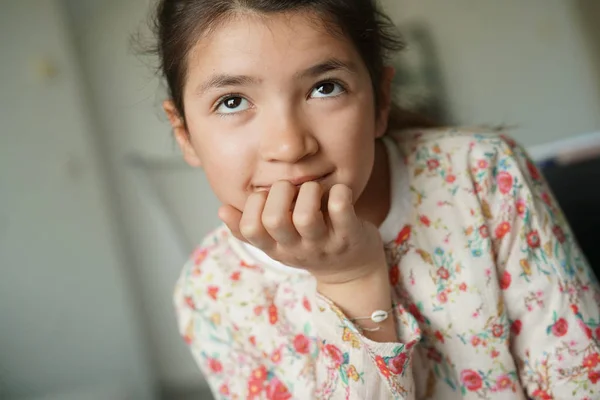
[355, 140, 391, 227]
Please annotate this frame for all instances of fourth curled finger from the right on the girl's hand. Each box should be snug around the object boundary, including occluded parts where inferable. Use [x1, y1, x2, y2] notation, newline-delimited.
[240, 192, 275, 251]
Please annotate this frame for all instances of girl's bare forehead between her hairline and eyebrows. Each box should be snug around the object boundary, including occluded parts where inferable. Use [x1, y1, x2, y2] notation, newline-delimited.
[188, 12, 362, 78]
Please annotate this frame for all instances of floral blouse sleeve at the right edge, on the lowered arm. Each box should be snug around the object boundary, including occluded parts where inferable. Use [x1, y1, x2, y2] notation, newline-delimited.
[472, 138, 600, 399]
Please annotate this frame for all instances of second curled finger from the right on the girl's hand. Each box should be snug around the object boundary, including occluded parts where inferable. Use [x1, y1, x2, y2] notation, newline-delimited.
[292, 182, 327, 241]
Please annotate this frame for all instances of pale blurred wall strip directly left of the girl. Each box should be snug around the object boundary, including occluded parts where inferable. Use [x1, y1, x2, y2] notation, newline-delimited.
[66, 0, 218, 392]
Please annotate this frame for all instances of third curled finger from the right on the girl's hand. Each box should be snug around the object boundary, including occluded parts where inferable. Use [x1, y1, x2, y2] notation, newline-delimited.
[262, 181, 300, 245]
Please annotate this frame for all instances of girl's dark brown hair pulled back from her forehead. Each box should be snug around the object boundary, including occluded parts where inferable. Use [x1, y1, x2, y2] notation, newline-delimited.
[151, 0, 430, 129]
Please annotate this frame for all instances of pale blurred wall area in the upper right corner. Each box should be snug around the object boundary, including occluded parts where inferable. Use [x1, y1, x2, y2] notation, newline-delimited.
[382, 0, 600, 145]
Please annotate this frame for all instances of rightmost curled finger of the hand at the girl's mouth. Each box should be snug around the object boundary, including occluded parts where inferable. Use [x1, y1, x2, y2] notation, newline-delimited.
[327, 184, 360, 237]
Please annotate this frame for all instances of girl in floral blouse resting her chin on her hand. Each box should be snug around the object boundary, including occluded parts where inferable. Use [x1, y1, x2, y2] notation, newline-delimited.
[151, 0, 600, 400]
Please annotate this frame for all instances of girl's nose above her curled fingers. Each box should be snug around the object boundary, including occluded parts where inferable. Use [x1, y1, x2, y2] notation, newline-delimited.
[260, 111, 319, 163]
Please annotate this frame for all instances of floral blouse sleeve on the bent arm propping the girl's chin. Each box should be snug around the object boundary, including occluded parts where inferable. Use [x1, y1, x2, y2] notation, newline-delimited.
[174, 233, 420, 400]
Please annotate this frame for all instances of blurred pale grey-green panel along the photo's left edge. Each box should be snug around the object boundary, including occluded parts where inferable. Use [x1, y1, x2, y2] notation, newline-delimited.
[0, 0, 153, 400]
